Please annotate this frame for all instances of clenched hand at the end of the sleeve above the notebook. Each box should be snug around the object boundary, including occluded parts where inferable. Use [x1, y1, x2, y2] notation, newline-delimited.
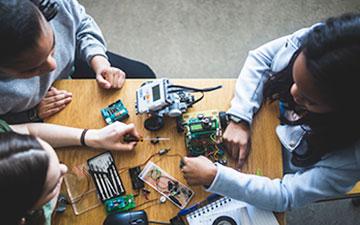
[181, 156, 217, 186]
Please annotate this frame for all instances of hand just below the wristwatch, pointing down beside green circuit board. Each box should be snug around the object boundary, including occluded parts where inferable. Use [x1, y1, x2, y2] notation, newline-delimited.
[223, 122, 251, 168]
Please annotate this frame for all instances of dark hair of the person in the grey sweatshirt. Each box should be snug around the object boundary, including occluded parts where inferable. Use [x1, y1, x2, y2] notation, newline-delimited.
[0, 0, 42, 67]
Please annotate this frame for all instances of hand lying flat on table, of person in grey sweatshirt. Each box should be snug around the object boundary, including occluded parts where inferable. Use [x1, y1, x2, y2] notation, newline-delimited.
[37, 87, 72, 119]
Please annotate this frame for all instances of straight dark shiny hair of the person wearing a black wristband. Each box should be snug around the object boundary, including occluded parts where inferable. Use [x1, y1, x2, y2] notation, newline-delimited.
[0, 132, 49, 225]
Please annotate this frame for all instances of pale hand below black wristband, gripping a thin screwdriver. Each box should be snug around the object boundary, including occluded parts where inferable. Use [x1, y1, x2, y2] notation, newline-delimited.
[85, 121, 141, 151]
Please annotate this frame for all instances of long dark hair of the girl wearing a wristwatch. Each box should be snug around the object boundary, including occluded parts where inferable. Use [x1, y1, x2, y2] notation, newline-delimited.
[263, 14, 360, 167]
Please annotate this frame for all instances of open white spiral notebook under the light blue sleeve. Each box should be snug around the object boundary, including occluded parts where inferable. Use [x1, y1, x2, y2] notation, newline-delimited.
[186, 197, 279, 225]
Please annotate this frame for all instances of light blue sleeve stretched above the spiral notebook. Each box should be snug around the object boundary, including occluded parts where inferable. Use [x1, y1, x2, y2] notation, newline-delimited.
[207, 164, 360, 212]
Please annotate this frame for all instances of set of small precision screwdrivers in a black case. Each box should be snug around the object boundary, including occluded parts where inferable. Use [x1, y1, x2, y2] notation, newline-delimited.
[87, 151, 125, 202]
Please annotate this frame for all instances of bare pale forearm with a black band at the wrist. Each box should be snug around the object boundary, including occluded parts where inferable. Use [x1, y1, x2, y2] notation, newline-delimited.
[11, 123, 96, 148]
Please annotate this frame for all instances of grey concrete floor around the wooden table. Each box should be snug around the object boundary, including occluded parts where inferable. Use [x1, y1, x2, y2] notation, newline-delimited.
[79, 0, 360, 225]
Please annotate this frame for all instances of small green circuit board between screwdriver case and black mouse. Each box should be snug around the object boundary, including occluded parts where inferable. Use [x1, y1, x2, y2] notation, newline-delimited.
[104, 194, 136, 214]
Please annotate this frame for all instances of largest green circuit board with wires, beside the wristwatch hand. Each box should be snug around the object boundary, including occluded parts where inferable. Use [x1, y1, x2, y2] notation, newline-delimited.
[181, 110, 227, 164]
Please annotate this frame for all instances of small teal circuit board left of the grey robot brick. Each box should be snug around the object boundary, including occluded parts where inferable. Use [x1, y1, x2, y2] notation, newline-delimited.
[101, 99, 129, 124]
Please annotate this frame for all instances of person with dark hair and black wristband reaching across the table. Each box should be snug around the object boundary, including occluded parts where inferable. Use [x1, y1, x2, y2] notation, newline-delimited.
[0, 120, 140, 225]
